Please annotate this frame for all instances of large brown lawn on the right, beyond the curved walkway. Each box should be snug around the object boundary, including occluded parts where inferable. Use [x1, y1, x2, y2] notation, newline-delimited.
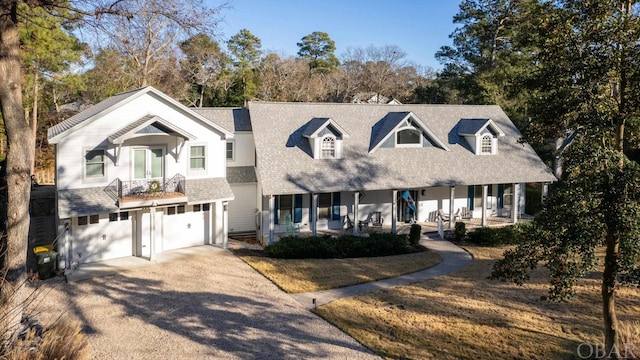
[316, 246, 640, 359]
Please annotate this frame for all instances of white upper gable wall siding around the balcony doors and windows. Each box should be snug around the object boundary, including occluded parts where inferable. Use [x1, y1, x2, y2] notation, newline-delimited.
[56, 96, 226, 189]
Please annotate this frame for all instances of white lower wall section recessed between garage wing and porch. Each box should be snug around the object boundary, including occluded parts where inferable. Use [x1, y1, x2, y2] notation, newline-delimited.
[229, 184, 257, 233]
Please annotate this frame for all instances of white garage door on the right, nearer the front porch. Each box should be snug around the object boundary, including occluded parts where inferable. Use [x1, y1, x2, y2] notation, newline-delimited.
[162, 205, 209, 251]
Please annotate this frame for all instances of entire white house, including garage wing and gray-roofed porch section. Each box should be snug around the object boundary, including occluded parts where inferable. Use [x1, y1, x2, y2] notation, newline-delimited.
[48, 87, 556, 266]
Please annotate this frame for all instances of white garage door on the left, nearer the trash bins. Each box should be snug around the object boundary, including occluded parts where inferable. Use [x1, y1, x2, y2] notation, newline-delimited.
[71, 214, 133, 263]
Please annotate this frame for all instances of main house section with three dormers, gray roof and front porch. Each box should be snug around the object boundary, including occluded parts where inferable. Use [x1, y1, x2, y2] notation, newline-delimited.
[242, 102, 556, 242]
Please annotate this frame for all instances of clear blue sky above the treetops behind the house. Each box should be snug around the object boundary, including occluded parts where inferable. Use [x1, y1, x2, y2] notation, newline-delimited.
[214, 0, 460, 70]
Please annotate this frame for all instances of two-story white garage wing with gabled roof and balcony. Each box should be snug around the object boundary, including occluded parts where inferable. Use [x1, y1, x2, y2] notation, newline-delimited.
[48, 87, 234, 267]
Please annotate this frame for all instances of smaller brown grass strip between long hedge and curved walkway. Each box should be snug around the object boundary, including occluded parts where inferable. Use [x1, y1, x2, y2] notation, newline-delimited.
[236, 250, 441, 293]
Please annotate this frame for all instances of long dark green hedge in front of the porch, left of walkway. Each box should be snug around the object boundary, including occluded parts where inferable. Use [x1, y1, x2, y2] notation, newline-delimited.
[264, 233, 416, 259]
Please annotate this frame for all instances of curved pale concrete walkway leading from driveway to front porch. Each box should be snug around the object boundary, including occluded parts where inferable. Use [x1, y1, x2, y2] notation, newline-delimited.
[291, 235, 473, 309]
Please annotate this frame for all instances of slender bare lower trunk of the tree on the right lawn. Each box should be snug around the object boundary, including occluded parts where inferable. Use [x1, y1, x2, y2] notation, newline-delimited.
[602, 234, 619, 359]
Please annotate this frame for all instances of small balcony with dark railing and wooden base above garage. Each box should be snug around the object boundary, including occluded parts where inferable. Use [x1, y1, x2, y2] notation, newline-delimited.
[104, 174, 187, 209]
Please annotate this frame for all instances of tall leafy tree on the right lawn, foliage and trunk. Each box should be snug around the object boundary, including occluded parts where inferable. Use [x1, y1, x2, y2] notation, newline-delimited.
[493, 0, 640, 358]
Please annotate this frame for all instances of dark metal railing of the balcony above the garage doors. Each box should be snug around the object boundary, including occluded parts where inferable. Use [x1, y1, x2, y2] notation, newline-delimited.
[104, 174, 186, 201]
